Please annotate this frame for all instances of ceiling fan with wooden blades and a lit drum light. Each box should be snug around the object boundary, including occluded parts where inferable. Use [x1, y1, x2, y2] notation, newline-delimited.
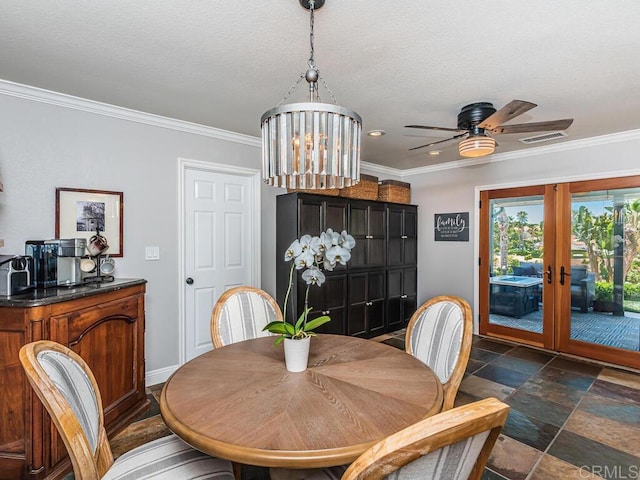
[405, 100, 573, 157]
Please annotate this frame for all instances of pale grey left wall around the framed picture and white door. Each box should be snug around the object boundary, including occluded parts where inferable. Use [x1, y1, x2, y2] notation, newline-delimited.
[0, 85, 283, 375]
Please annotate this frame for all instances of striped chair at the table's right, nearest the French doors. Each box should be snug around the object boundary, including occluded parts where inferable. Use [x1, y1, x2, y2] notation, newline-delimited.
[405, 296, 473, 410]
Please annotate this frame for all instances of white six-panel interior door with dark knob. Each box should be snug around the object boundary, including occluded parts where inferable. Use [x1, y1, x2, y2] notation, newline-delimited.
[183, 168, 257, 361]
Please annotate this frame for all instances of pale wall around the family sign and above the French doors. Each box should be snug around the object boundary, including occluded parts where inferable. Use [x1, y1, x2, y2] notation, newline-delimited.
[403, 131, 640, 322]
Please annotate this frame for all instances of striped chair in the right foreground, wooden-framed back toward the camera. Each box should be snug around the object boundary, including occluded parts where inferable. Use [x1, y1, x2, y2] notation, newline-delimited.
[272, 398, 509, 480]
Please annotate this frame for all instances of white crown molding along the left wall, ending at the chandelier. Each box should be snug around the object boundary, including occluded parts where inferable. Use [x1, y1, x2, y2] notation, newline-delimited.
[0, 80, 261, 147]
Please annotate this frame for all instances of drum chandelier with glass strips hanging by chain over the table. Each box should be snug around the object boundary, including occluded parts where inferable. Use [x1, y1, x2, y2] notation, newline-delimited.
[260, 0, 362, 189]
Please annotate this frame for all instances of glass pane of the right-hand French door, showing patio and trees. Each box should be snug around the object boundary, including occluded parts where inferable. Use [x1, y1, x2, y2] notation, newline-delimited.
[569, 188, 640, 351]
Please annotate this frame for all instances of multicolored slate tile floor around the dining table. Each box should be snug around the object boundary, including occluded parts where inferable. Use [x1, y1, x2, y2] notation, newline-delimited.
[69, 331, 640, 480]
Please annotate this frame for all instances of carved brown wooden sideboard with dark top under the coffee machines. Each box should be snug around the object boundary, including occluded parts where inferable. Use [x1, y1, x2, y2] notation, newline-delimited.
[0, 279, 149, 480]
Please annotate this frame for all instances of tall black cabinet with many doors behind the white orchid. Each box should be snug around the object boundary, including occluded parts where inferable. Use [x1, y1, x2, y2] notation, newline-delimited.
[276, 193, 418, 338]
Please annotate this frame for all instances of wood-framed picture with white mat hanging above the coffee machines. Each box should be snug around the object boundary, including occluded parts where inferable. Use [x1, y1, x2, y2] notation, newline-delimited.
[55, 188, 124, 257]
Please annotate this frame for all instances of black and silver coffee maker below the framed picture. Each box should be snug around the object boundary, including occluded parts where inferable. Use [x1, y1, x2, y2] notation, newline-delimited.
[25, 238, 87, 288]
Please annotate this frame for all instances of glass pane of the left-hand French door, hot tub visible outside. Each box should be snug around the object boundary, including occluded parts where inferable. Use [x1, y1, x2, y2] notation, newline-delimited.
[489, 195, 544, 333]
